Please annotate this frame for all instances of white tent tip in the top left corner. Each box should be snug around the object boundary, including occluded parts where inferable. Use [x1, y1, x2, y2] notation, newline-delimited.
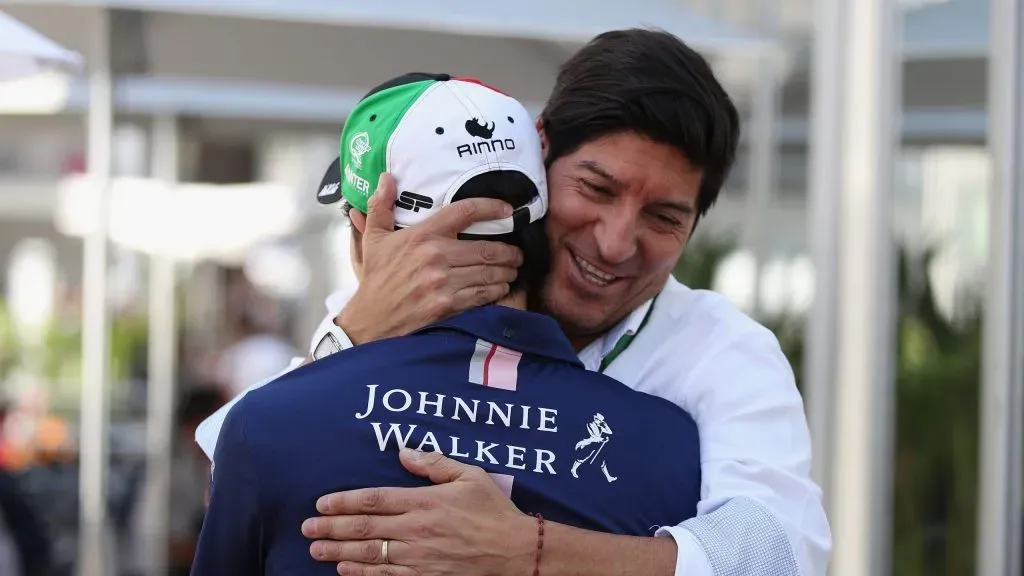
[0, 12, 82, 81]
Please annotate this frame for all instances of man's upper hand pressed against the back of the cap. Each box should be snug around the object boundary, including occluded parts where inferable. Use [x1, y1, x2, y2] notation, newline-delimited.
[335, 174, 522, 344]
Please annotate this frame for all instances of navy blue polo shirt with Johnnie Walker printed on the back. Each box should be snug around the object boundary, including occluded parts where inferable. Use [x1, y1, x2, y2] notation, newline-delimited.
[193, 305, 700, 576]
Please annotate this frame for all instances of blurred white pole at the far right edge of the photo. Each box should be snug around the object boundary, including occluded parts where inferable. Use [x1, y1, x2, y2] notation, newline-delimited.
[977, 0, 1024, 576]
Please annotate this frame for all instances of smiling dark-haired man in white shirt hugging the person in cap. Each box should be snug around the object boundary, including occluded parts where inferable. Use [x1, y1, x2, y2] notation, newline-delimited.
[198, 30, 830, 576]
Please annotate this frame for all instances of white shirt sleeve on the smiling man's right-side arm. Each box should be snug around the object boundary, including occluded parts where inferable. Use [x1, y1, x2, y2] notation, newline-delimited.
[657, 329, 831, 576]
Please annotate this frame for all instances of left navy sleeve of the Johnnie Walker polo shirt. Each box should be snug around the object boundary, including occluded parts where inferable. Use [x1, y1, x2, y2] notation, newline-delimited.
[191, 404, 263, 576]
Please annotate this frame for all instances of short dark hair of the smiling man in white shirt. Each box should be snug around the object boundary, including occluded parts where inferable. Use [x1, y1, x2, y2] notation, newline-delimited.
[541, 29, 739, 218]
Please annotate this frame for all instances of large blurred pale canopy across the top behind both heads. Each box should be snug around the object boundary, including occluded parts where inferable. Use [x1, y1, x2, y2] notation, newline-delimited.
[0, 0, 769, 123]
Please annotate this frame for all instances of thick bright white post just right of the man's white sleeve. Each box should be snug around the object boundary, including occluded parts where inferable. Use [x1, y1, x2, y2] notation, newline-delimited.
[831, 0, 901, 576]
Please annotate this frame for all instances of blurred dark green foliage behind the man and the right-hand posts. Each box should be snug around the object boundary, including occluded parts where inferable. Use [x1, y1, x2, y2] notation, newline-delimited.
[675, 236, 981, 576]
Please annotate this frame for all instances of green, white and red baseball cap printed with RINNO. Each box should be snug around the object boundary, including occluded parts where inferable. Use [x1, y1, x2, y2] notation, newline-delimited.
[316, 73, 548, 236]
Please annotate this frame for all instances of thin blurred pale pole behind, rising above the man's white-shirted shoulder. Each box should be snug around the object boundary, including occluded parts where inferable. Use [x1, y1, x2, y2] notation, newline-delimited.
[745, 0, 780, 318]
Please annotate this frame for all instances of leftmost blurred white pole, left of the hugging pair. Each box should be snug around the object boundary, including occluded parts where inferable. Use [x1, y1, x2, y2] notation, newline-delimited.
[79, 5, 114, 576]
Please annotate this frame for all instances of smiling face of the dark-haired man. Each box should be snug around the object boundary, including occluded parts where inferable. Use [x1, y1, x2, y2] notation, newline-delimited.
[544, 132, 702, 347]
